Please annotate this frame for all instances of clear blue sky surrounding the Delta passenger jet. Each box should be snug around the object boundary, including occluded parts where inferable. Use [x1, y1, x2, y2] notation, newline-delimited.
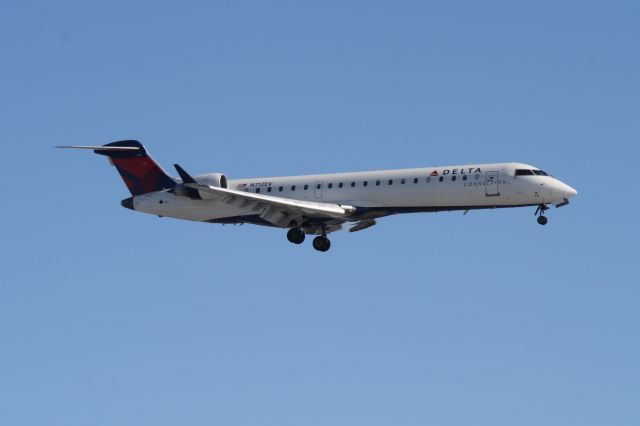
[0, 1, 640, 426]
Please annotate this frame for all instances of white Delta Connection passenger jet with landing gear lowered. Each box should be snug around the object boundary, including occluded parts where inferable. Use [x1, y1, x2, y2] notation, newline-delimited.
[56, 140, 577, 252]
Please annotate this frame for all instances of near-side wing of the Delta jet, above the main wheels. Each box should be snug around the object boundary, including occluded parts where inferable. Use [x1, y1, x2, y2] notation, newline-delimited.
[183, 183, 356, 227]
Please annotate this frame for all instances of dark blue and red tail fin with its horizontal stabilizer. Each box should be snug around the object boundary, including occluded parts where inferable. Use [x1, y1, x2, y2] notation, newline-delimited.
[59, 140, 176, 195]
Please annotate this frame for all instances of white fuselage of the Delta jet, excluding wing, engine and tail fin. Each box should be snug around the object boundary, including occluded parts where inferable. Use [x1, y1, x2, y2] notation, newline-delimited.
[133, 163, 576, 223]
